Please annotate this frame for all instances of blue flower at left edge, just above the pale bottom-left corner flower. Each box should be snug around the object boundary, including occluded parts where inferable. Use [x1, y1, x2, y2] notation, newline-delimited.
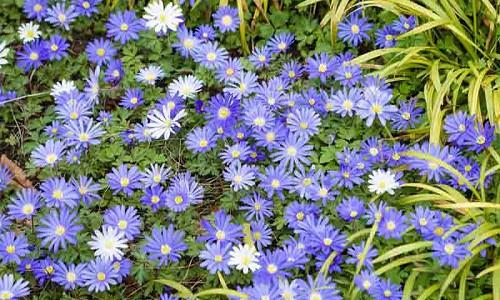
[0, 231, 31, 264]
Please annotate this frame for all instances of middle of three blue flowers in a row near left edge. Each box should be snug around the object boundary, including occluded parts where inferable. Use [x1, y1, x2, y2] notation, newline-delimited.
[40, 177, 80, 208]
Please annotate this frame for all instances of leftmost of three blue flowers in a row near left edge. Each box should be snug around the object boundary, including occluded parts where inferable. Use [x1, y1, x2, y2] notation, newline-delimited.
[7, 188, 42, 220]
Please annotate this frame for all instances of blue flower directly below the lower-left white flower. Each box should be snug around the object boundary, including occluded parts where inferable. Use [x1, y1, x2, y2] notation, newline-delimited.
[81, 258, 118, 292]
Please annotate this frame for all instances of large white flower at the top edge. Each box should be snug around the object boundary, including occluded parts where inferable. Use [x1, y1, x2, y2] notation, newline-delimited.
[143, 0, 184, 33]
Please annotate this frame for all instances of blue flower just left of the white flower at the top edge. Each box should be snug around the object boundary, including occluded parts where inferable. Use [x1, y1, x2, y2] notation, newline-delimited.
[106, 10, 143, 45]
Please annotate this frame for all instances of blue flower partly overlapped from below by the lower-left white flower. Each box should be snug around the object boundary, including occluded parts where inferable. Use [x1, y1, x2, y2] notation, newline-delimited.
[104, 205, 141, 241]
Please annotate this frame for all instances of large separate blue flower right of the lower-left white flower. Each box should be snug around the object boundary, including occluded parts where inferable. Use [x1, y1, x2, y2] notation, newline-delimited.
[142, 224, 187, 267]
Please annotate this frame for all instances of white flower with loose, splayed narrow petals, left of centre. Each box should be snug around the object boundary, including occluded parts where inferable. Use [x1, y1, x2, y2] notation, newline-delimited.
[146, 105, 186, 140]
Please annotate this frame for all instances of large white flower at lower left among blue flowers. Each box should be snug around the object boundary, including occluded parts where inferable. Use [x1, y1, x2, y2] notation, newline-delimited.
[88, 226, 128, 261]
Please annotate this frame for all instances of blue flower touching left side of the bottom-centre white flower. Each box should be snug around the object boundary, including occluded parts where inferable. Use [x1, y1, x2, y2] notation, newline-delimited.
[200, 242, 231, 274]
